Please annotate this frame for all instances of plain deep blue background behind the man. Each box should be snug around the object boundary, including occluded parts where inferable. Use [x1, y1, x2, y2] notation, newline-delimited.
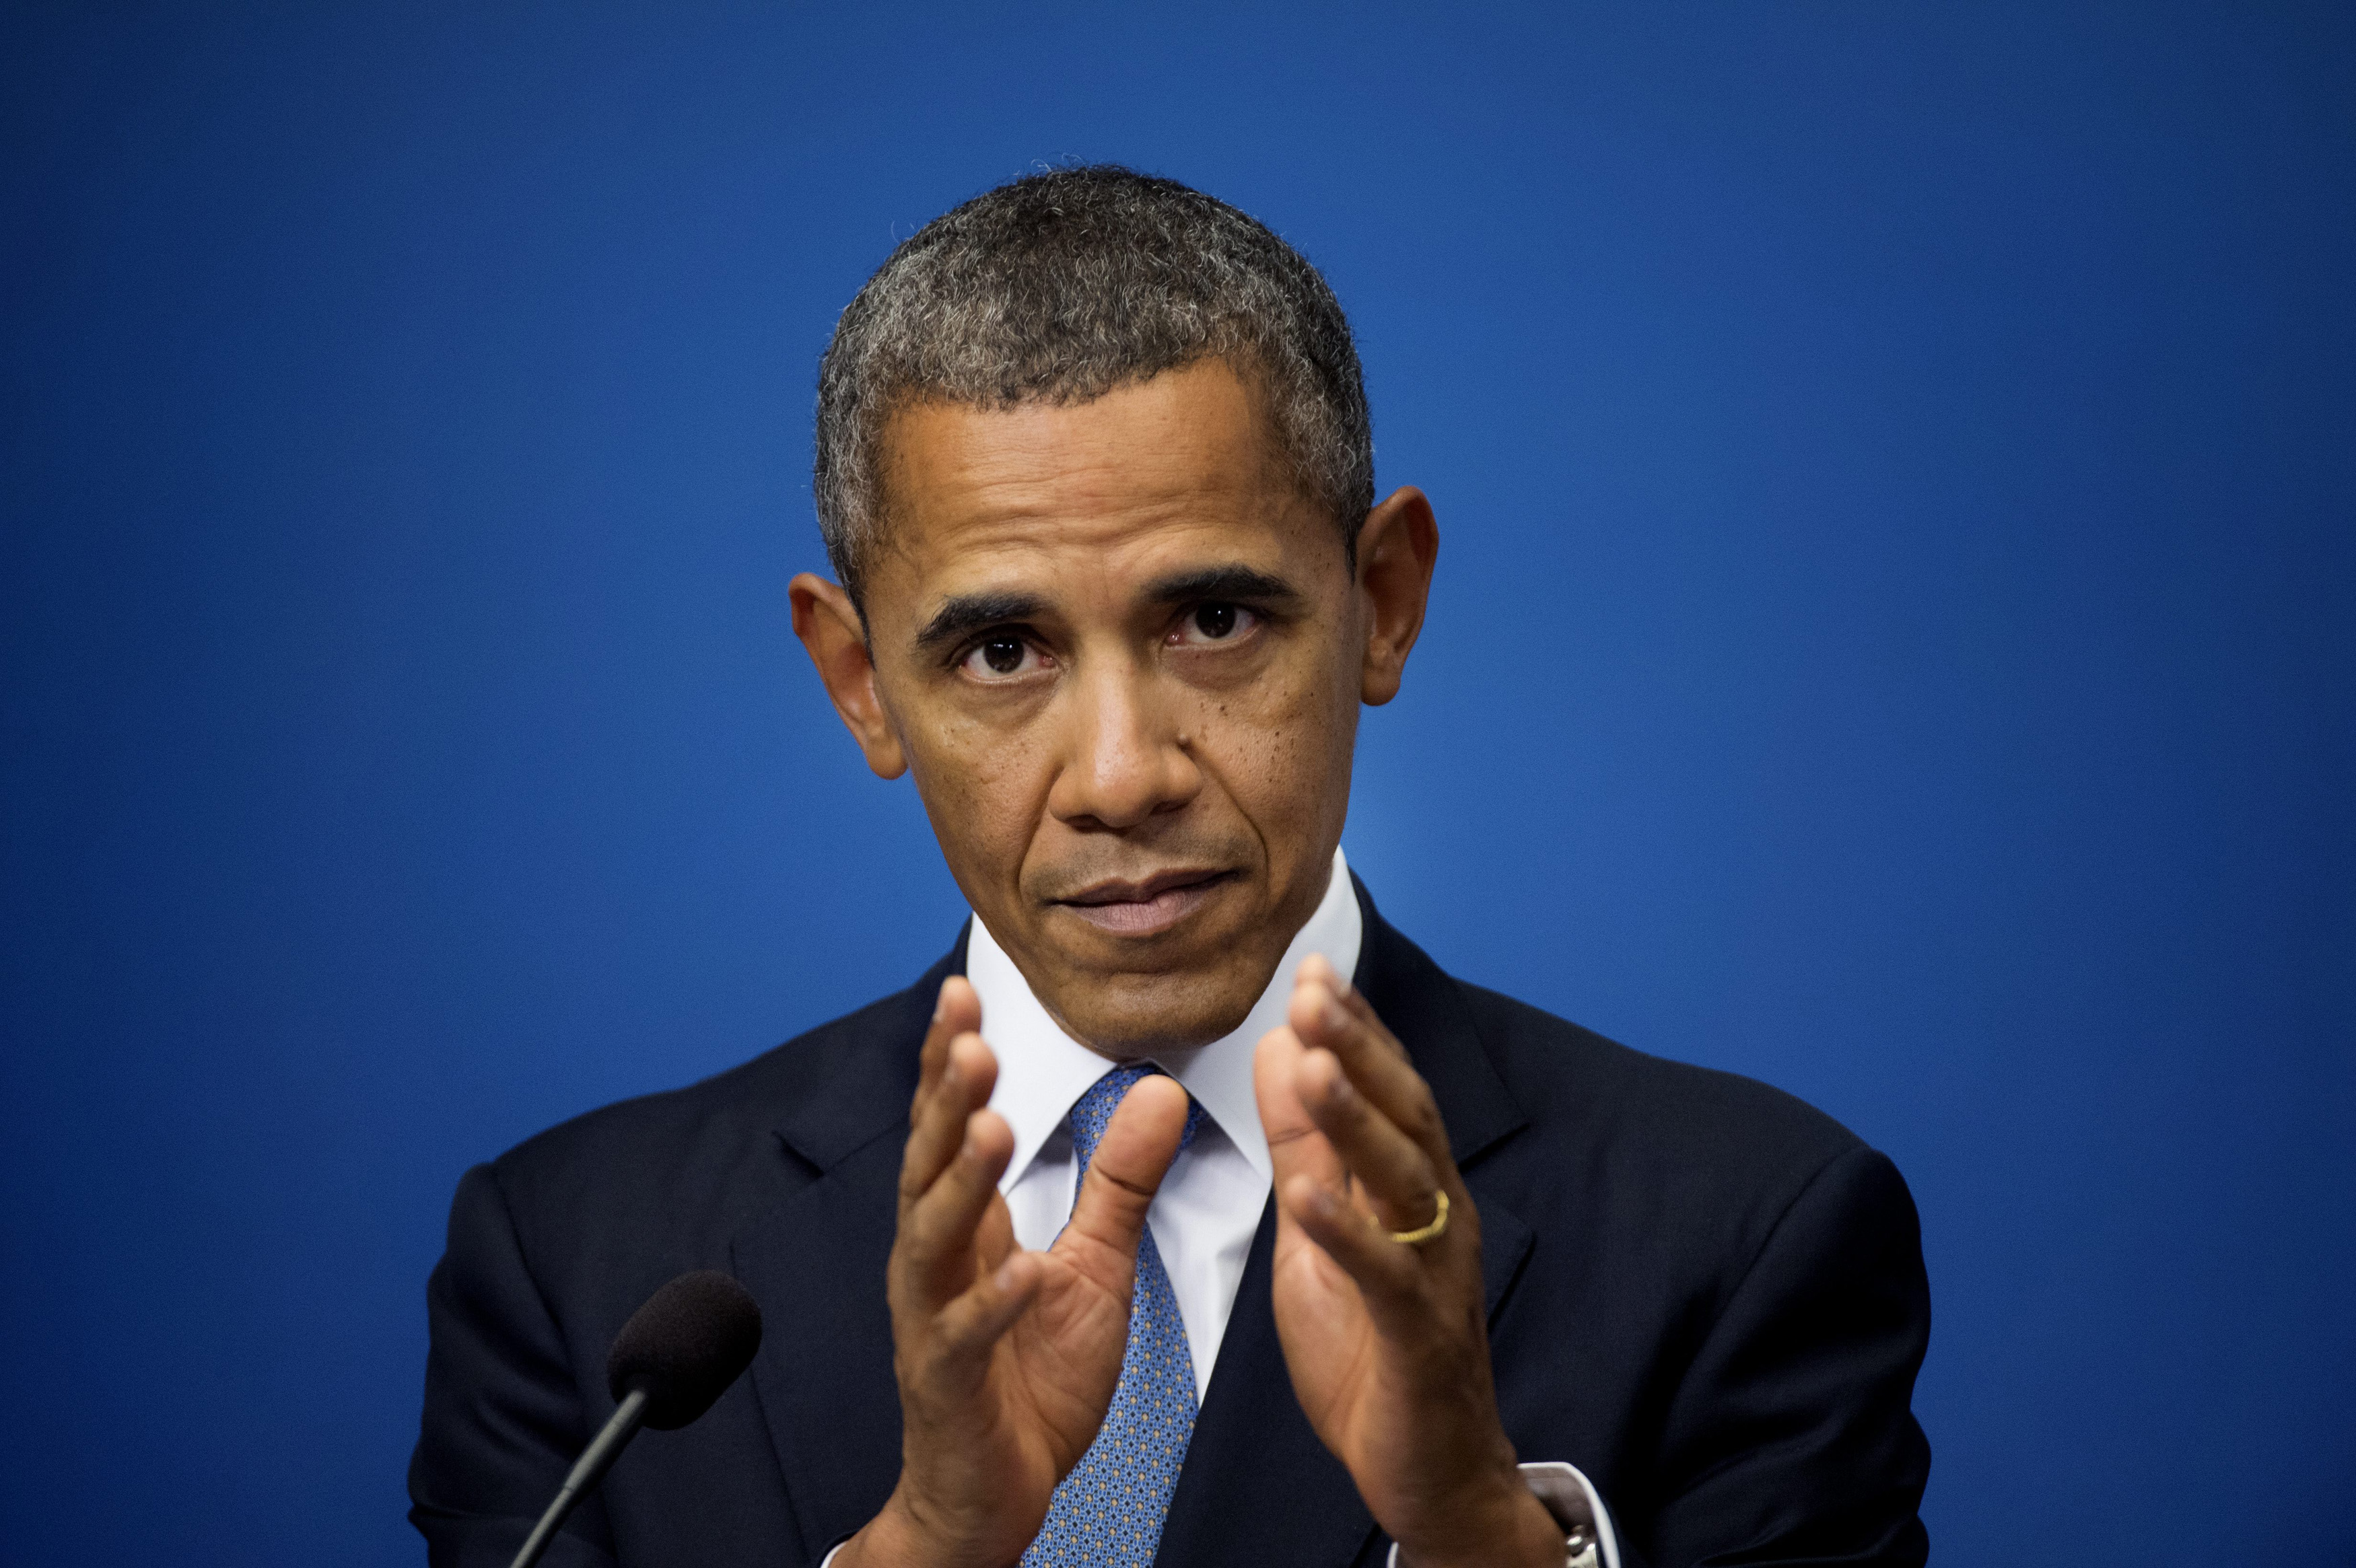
[0, 2, 2356, 1563]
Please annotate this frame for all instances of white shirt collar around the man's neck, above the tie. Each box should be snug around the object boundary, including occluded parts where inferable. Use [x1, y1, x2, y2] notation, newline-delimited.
[966, 847, 1364, 1191]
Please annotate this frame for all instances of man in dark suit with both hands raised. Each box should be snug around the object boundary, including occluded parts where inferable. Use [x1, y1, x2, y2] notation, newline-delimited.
[410, 170, 1930, 1568]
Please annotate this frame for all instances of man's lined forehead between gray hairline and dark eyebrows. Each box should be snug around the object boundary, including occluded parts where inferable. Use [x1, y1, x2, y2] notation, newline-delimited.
[867, 360, 1341, 617]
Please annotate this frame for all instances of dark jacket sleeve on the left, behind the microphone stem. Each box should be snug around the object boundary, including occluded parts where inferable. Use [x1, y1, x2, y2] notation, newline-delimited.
[410, 1166, 615, 1568]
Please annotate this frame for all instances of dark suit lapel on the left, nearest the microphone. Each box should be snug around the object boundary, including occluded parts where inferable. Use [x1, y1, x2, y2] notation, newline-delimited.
[730, 937, 966, 1563]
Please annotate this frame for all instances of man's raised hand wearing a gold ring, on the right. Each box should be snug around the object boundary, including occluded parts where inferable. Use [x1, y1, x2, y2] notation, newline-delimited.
[1253, 958, 1564, 1568]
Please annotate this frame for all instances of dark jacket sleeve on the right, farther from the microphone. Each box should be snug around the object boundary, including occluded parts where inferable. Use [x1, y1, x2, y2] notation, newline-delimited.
[1624, 1147, 1930, 1568]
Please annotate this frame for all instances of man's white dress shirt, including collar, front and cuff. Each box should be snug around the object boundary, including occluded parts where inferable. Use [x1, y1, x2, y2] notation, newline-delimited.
[827, 850, 1619, 1568]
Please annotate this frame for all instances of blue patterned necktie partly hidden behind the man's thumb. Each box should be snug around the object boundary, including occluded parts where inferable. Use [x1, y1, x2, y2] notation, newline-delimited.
[1023, 1062, 1202, 1568]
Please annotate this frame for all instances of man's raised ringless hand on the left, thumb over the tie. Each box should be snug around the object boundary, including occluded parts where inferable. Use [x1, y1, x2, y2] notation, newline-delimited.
[834, 974, 1187, 1568]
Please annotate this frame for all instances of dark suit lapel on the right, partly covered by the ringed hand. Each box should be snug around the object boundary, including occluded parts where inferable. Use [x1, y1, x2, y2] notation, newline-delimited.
[1154, 878, 1531, 1568]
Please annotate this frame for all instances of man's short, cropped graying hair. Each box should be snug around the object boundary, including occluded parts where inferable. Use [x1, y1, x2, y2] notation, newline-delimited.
[810, 165, 1374, 603]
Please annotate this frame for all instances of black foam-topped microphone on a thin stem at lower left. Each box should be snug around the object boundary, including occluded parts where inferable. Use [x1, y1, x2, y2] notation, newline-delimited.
[512, 1269, 761, 1568]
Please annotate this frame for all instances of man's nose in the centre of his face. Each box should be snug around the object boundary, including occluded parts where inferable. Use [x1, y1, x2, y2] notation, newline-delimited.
[1046, 660, 1202, 833]
